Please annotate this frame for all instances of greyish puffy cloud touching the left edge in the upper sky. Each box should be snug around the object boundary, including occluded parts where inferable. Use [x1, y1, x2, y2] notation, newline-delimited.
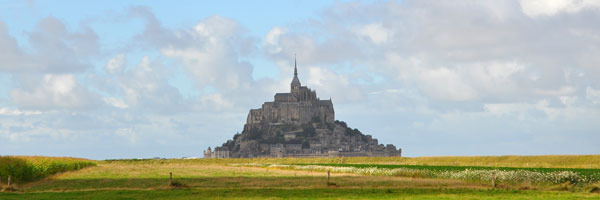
[0, 17, 98, 73]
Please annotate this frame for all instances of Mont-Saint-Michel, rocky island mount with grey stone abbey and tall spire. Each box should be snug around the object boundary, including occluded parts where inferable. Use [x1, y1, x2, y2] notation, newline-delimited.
[204, 61, 402, 158]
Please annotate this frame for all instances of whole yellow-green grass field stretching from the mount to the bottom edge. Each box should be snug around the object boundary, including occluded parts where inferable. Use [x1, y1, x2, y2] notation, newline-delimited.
[0, 155, 600, 199]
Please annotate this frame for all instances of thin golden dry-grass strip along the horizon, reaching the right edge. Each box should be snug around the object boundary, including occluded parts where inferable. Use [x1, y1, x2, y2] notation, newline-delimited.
[110, 155, 600, 169]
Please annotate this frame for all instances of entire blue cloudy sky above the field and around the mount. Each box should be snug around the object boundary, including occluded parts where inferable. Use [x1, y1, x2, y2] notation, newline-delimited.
[0, 0, 600, 159]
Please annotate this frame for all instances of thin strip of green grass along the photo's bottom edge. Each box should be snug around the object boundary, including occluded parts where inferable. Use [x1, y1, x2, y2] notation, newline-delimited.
[0, 188, 600, 200]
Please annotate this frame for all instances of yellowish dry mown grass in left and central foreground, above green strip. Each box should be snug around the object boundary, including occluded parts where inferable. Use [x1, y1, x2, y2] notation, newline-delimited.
[22, 163, 487, 192]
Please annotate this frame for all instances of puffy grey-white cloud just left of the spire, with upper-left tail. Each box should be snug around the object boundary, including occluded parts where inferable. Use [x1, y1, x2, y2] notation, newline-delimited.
[135, 8, 274, 111]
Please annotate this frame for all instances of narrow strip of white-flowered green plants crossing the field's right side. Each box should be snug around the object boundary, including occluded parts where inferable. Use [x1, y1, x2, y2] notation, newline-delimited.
[242, 164, 600, 184]
